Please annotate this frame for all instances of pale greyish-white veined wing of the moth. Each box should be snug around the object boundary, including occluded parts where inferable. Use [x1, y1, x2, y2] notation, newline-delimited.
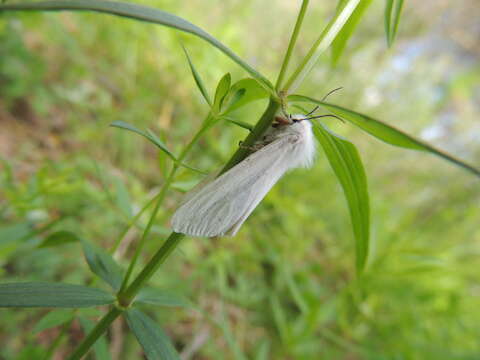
[172, 134, 299, 237]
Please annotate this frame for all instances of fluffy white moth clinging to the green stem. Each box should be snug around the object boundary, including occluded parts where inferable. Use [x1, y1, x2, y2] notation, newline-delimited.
[172, 115, 315, 237]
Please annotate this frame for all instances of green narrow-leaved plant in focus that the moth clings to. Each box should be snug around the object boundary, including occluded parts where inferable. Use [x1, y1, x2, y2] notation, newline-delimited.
[0, 0, 480, 360]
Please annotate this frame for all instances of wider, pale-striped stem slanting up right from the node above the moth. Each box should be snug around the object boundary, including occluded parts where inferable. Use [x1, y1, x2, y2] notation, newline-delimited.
[282, 0, 360, 95]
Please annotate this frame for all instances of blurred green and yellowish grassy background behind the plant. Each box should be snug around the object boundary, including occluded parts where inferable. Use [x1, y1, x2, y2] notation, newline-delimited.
[0, 0, 480, 360]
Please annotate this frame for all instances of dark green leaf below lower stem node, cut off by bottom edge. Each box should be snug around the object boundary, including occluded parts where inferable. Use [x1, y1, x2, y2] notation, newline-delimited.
[125, 308, 180, 360]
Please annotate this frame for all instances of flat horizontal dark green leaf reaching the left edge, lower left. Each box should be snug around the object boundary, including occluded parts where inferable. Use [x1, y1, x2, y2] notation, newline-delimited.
[0, 282, 115, 308]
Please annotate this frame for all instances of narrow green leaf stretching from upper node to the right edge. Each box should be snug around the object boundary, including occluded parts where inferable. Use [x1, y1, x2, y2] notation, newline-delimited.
[288, 95, 480, 177]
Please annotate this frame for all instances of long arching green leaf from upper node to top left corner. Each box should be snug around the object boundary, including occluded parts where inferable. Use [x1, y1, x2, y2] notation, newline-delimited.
[0, 0, 274, 95]
